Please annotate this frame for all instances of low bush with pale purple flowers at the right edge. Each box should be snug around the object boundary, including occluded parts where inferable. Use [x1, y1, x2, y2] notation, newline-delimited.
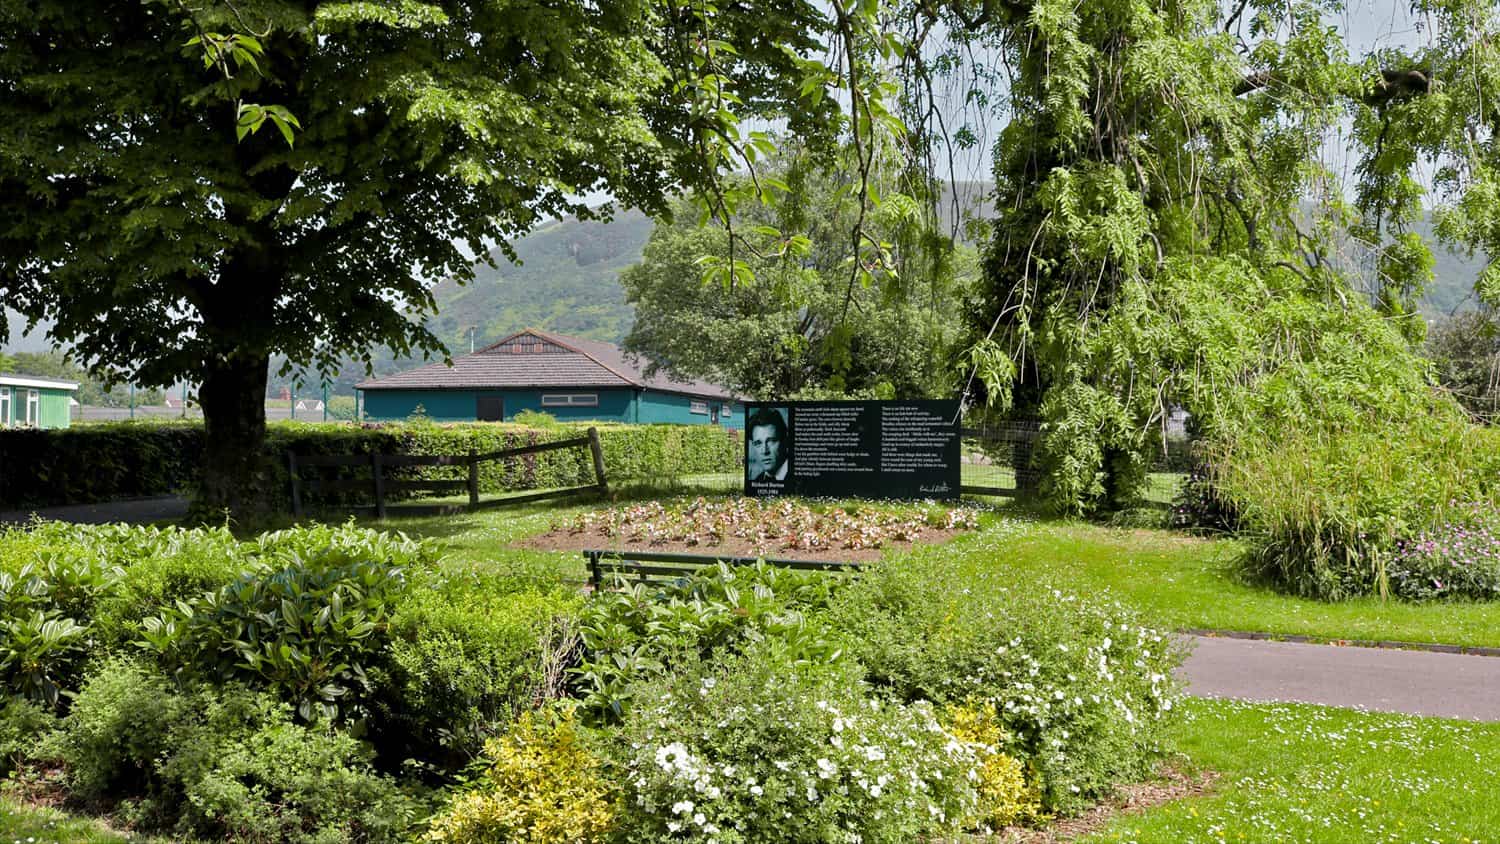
[1386, 505, 1500, 601]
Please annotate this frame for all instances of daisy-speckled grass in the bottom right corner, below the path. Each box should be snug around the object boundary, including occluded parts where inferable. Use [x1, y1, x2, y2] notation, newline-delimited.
[1085, 700, 1500, 844]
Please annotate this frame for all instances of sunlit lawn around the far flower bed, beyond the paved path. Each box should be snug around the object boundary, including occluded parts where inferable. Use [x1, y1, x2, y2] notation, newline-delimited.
[360, 502, 1500, 646]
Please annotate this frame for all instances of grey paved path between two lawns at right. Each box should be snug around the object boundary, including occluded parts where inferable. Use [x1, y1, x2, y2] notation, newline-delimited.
[1179, 636, 1500, 721]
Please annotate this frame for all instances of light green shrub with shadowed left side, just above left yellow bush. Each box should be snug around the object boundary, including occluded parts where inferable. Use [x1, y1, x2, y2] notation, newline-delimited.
[374, 571, 584, 765]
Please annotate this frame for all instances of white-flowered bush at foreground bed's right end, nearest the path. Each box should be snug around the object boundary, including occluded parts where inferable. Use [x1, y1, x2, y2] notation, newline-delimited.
[828, 555, 1181, 811]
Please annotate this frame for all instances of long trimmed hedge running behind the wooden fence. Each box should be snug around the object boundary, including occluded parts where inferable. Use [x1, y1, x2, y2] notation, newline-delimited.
[0, 421, 743, 510]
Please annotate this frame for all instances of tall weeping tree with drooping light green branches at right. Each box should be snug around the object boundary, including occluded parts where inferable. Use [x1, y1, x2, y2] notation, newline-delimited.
[930, 0, 1500, 511]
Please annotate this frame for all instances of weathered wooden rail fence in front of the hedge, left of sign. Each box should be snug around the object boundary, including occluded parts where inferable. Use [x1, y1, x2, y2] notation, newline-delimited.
[287, 427, 609, 519]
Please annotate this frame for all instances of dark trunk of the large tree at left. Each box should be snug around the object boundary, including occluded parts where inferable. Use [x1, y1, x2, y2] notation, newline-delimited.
[189, 354, 276, 525]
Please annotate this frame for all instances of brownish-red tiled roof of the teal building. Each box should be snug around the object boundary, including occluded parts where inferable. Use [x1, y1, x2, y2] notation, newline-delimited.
[357, 328, 734, 399]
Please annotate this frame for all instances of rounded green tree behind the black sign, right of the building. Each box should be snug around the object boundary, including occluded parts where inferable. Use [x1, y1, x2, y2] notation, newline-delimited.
[620, 156, 978, 399]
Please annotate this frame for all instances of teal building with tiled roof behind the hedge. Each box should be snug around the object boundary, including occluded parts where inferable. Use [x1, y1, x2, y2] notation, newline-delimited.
[356, 328, 744, 429]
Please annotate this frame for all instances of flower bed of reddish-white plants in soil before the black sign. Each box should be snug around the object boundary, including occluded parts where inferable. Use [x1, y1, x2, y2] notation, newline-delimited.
[525, 498, 980, 562]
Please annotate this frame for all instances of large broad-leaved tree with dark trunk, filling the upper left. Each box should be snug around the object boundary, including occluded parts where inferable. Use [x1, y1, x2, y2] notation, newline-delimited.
[0, 0, 822, 517]
